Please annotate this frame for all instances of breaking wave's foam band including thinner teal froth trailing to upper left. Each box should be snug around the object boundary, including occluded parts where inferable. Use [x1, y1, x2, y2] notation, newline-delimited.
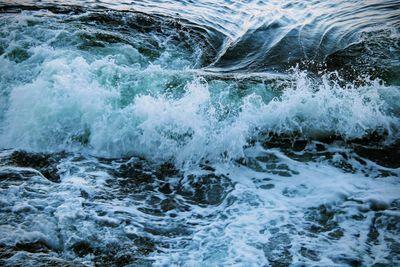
[0, 12, 400, 162]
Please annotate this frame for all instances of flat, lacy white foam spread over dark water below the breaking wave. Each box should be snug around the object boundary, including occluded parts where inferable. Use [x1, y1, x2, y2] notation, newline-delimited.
[0, 147, 399, 266]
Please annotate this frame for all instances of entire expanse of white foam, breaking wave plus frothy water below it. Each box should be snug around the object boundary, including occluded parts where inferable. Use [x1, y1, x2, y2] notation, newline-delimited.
[0, 8, 400, 266]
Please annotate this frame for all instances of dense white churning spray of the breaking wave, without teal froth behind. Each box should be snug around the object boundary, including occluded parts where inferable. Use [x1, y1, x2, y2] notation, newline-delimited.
[0, 48, 400, 161]
